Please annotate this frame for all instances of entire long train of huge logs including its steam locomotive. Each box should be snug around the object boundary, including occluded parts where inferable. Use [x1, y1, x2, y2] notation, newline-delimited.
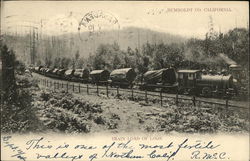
[31, 66, 246, 97]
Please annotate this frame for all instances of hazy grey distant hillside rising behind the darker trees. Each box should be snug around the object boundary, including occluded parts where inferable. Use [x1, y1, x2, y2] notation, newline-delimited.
[3, 27, 186, 64]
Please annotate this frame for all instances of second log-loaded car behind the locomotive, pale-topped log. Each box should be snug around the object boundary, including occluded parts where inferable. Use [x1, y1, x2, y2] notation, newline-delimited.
[110, 68, 136, 88]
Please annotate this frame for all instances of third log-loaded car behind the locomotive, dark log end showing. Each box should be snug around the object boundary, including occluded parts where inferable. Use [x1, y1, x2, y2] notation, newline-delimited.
[89, 70, 110, 84]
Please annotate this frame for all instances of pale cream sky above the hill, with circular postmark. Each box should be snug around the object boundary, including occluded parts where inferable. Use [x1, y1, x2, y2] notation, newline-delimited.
[1, 1, 249, 38]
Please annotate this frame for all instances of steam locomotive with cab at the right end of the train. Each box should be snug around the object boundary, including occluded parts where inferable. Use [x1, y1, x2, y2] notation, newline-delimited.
[178, 70, 236, 97]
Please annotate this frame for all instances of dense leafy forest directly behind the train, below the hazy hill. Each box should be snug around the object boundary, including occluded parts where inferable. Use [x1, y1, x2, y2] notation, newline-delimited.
[45, 28, 249, 76]
